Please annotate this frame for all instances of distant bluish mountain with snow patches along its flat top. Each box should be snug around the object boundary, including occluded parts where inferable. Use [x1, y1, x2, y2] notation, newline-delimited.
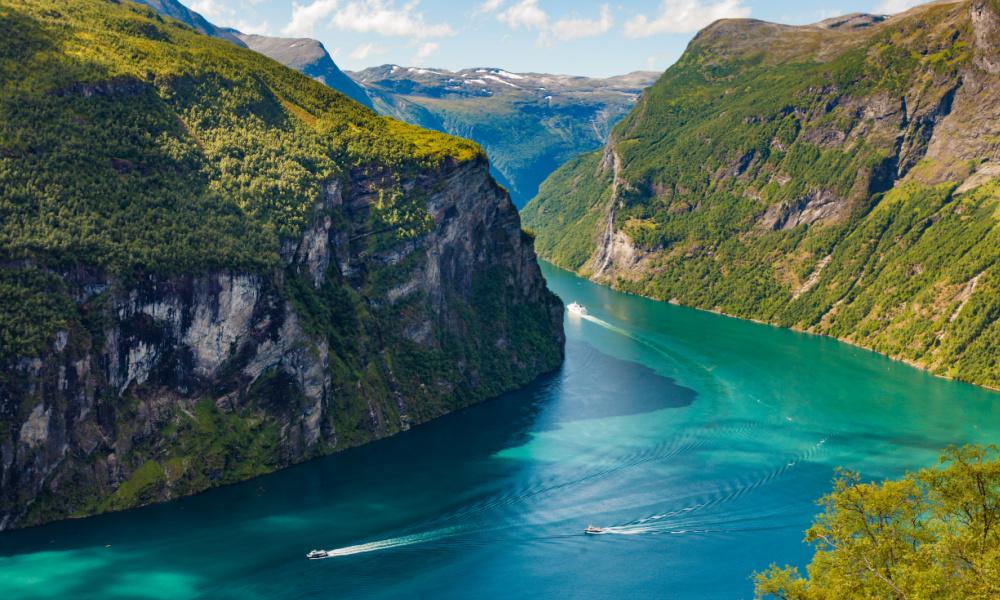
[349, 65, 658, 206]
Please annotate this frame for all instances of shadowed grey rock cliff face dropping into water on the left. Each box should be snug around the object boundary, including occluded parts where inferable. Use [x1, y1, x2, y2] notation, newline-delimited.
[0, 159, 564, 530]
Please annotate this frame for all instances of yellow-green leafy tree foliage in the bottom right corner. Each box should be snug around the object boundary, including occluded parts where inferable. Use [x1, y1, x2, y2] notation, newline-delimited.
[755, 446, 1000, 600]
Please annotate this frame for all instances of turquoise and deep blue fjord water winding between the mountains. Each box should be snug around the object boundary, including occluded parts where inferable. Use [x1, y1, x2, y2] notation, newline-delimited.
[0, 267, 1000, 599]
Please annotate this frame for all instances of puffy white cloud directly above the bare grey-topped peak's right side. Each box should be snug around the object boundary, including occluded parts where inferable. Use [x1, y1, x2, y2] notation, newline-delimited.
[332, 0, 455, 39]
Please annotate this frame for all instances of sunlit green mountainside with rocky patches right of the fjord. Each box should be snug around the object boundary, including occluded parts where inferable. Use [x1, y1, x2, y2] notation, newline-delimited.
[522, 0, 1000, 388]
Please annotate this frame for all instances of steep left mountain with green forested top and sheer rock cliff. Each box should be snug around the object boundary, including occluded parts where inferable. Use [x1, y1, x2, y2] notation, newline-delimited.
[0, 0, 563, 529]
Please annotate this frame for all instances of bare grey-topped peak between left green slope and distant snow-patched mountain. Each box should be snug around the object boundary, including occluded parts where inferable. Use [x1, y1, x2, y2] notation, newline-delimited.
[234, 32, 372, 108]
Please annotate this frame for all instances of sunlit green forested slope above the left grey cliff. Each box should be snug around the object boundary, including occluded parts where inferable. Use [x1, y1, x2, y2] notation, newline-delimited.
[0, 0, 481, 358]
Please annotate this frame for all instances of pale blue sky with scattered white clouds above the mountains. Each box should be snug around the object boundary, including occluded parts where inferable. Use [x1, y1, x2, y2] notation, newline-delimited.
[191, 0, 932, 77]
